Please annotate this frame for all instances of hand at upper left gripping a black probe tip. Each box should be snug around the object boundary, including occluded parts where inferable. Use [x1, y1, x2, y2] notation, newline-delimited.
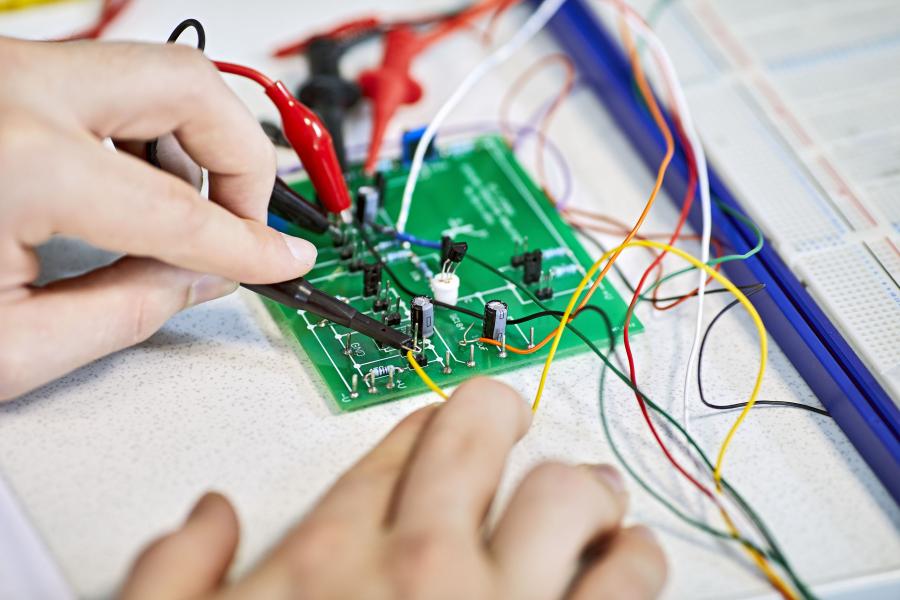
[0, 38, 316, 401]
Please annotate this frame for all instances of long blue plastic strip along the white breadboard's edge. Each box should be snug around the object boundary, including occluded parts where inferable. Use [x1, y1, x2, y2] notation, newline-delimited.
[549, 0, 900, 503]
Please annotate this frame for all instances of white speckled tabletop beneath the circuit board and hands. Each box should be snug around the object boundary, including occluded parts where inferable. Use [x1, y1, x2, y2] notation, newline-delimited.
[0, 0, 900, 598]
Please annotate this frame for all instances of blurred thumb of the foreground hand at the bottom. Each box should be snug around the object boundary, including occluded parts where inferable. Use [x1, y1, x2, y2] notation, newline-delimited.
[121, 492, 238, 600]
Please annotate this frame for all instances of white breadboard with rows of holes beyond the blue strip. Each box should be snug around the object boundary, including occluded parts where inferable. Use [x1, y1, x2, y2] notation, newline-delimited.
[624, 0, 900, 404]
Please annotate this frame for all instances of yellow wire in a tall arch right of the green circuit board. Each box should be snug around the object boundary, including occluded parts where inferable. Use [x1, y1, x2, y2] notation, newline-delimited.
[531, 240, 768, 490]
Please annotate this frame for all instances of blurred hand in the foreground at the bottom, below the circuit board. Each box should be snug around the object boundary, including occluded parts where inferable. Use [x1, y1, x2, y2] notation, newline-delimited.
[122, 379, 666, 600]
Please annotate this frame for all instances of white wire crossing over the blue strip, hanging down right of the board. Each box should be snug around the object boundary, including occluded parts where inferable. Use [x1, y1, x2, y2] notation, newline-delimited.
[616, 7, 712, 433]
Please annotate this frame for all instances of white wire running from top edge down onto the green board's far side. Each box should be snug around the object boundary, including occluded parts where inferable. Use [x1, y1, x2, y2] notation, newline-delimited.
[395, 0, 566, 233]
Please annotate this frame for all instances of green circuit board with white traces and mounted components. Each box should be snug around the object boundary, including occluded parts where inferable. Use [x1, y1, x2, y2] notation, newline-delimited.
[265, 136, 643, 411]
